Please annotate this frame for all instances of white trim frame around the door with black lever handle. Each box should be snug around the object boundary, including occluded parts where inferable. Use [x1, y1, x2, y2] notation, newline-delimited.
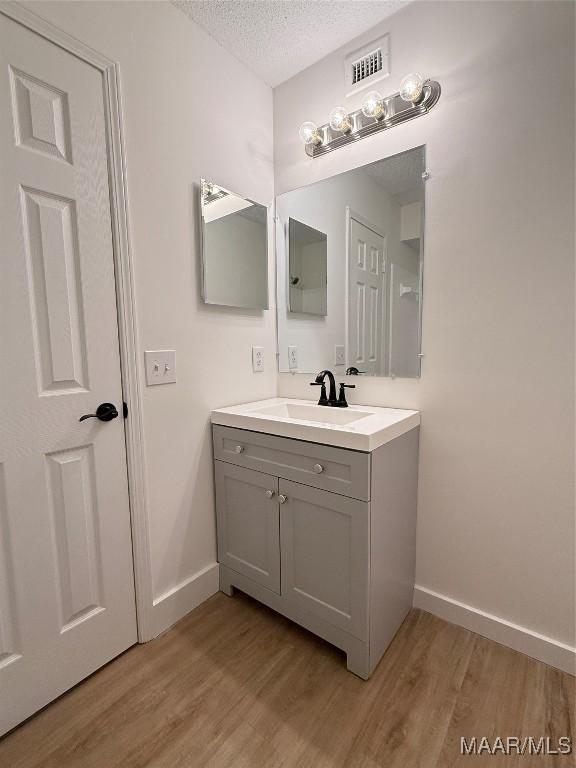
[0, 2, 154, 643]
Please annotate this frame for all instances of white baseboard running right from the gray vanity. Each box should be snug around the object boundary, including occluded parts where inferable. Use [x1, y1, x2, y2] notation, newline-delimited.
[414, 585, 576, 675]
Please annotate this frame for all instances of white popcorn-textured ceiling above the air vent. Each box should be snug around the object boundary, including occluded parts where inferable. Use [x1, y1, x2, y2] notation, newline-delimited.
[172, 0, 409, 86]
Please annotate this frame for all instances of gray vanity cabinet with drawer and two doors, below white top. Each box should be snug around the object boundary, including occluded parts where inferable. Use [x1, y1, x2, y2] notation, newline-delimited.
[213, 424, 419, 679]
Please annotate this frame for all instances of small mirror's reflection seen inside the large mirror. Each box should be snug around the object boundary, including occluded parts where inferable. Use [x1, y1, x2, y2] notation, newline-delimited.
[288, 218, 328, 316]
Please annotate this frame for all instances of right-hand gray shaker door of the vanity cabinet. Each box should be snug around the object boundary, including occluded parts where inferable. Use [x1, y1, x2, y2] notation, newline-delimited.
[279, 480, 370, 640]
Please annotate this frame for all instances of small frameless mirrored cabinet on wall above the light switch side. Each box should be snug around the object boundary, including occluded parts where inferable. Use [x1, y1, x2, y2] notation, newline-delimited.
[200, 179, 268, 309]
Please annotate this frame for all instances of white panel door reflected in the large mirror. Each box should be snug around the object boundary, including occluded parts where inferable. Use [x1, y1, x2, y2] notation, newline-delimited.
[347, 219, 386, 375]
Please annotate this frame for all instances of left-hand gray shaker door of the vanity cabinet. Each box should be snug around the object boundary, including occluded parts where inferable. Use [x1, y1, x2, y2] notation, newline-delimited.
[215, 461, 280, 593]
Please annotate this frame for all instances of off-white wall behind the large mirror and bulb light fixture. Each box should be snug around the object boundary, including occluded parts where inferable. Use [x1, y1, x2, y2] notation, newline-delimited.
[274, 2, 575, 660]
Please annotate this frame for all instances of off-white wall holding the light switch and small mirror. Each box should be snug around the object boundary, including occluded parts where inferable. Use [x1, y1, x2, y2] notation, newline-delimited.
[26, 2, 276, 631]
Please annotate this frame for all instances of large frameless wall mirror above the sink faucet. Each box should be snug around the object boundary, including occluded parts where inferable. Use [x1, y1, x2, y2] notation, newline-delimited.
[276, 147, 425, 377]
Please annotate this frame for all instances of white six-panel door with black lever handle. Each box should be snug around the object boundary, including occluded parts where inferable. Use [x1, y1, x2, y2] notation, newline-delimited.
[0, 15, 136, 733]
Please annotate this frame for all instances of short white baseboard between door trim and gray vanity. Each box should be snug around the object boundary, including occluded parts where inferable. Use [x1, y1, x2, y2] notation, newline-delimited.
[152, 563, 219, 637]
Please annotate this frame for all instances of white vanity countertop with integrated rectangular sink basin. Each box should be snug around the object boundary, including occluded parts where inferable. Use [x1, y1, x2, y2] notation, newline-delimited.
[211, 397, 420, 451]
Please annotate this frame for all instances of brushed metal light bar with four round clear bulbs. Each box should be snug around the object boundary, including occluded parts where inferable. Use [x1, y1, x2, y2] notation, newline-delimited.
[300, 72, 441, 157]
